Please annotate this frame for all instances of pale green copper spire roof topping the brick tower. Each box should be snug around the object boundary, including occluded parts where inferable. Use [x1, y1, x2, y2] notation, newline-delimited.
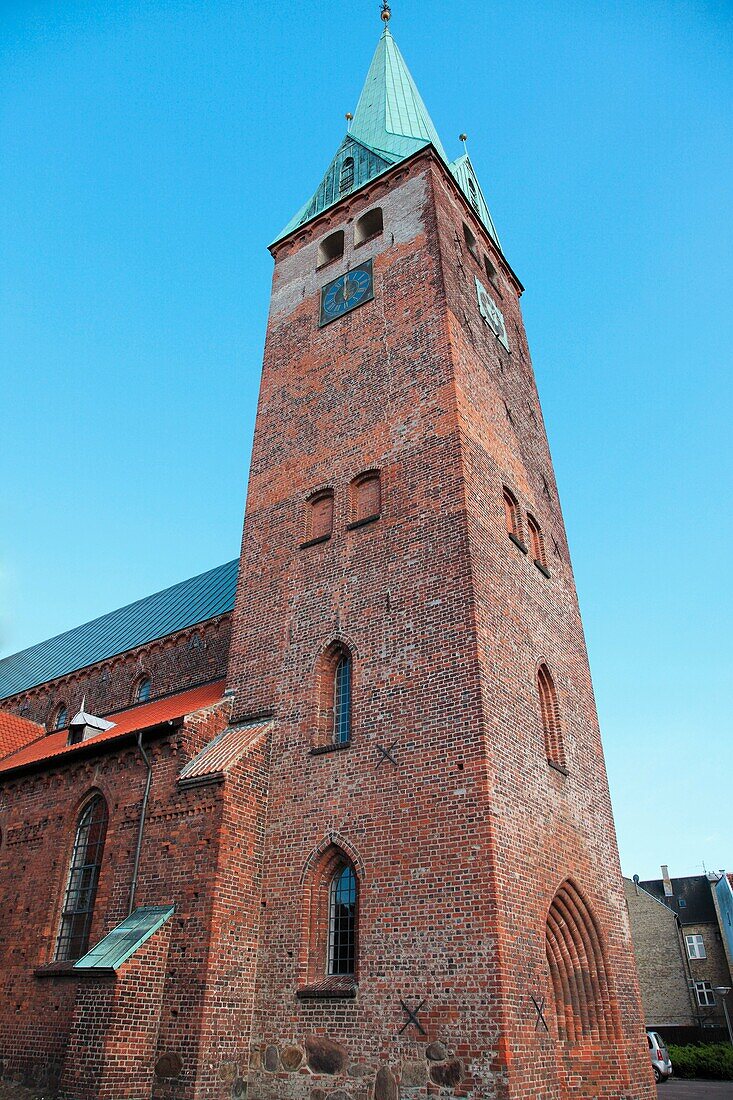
[270, 26, 501, 246]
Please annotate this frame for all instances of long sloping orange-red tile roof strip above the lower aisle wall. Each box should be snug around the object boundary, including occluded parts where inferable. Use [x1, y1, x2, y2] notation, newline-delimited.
[0, 680, 225, 773]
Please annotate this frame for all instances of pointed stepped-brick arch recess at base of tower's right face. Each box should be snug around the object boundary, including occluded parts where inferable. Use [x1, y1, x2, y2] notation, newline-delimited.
[546, 882, 616, 1043]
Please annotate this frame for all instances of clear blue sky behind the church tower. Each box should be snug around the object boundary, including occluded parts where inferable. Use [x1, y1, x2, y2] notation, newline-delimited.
[0, 0, 733, 878]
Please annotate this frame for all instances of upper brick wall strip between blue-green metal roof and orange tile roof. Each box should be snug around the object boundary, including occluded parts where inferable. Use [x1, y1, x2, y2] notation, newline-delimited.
[2, 615, 231, 729]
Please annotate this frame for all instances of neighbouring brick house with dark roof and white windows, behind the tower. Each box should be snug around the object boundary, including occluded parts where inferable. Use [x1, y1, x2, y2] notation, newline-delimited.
[624, 865, 733, 1038]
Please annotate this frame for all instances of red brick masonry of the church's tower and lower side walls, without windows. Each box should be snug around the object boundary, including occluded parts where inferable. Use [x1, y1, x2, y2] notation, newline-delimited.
[0, 150, 654, 1100]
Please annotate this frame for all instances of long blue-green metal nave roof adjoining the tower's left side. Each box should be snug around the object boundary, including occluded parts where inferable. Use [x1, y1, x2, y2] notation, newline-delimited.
[0, 559, 239, 699]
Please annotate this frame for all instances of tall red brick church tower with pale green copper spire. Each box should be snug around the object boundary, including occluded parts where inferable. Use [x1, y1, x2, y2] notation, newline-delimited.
[228, 10, 655, 1100]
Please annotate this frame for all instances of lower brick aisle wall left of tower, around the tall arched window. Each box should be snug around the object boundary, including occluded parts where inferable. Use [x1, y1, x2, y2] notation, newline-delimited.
[0, 704, 239, 1100]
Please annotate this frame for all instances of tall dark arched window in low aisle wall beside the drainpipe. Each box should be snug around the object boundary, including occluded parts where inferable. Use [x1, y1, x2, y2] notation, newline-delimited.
[56, 794, 107, 959]
